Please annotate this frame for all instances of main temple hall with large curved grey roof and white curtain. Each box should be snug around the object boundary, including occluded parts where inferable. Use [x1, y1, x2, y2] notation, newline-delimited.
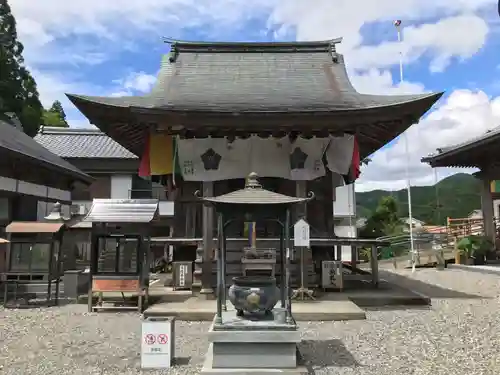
[68, 39, 442, 293]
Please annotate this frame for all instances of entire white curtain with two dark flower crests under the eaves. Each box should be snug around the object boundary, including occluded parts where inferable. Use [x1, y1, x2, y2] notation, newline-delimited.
[177, 135, 354, 181]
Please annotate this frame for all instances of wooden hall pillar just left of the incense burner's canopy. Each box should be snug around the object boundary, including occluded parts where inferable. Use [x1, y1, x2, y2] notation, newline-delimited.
[200, 181, 214, 298]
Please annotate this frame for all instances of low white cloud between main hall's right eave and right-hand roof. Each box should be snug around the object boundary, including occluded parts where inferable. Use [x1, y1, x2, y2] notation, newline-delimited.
[356, 90, 500, 191]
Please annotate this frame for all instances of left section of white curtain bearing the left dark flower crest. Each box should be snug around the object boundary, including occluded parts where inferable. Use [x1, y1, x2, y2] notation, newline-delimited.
[177, 137, 250, 181]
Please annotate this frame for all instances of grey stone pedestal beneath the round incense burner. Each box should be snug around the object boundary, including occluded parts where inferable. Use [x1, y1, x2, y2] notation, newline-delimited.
[201, 311, 307, 375]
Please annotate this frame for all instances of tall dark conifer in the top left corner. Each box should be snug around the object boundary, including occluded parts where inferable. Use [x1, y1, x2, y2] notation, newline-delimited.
[0, 0, 43, 136]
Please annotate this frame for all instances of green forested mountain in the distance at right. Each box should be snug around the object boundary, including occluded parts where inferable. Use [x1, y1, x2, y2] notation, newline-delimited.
[356, 173, 481, 225]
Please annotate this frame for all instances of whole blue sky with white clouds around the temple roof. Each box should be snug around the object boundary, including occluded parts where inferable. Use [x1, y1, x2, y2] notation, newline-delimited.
[9, 0, 500, 190]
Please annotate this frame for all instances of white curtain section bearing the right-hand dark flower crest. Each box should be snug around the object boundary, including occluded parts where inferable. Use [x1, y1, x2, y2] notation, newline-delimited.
[289, 137, 330, 181]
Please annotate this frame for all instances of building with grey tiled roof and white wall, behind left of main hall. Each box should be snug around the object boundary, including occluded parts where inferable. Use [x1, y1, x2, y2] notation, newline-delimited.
[34, 127, 174, 269]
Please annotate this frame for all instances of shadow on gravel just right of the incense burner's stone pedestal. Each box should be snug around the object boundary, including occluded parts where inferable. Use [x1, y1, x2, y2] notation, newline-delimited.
[299, 339, 360, 374]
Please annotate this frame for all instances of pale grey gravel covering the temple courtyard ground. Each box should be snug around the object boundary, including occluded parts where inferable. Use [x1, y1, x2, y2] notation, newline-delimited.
[0, 269, 500, 375]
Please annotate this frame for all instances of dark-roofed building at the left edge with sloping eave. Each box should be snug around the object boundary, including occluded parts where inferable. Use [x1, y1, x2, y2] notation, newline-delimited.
[0, 117, 93, 273]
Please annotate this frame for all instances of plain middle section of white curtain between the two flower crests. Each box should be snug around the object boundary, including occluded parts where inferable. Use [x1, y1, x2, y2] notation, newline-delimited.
[247, 135, 290, 179]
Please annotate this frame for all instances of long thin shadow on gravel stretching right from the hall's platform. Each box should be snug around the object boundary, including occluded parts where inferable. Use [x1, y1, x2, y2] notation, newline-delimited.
[379, 270, 488, 299]
